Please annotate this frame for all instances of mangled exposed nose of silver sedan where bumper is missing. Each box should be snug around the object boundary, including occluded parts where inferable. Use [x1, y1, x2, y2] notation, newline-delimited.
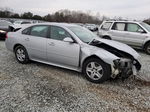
[114, 58, 141, 79]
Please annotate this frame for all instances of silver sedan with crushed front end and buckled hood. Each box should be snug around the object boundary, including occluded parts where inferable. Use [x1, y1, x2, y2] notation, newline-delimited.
[6, 23, 141, 83]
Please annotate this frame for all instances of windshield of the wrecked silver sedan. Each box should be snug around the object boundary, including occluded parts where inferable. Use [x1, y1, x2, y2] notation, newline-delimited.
[68, 26, 97, 43]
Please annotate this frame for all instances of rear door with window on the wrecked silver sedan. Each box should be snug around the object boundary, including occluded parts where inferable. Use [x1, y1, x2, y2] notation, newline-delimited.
[23, 25, 49, 61]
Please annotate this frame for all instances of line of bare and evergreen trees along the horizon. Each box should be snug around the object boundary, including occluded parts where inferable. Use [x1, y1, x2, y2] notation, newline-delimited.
[0, 10, 101, 24]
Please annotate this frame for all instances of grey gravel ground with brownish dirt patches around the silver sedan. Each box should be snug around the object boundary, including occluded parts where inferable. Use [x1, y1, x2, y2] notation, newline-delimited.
[0, 41, 150, 112]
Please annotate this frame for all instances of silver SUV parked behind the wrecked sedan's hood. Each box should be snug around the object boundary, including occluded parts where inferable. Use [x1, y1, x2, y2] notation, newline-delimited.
[98, 21, 150, 54]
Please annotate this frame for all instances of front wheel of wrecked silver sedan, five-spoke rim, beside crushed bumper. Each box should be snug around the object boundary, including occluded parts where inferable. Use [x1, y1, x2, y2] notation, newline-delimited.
[83, 58, 111, 83]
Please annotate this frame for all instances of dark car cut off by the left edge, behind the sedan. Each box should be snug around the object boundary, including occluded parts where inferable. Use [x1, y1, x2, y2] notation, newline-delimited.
[0, 20, 12, 40]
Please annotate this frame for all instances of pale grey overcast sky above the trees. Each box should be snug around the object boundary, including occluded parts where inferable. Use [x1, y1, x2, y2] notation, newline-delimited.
[0, 0, 150, 19]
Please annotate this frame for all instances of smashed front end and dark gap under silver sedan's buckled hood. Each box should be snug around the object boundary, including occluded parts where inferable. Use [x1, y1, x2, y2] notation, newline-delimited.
[90, 40, 141, 79]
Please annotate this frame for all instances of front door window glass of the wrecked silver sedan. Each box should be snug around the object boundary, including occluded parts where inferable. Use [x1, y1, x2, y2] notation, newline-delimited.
[50, 26, 71, 40]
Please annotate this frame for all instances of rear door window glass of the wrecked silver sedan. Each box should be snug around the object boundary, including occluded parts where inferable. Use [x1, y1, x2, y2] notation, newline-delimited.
[30, 25, 48, 37]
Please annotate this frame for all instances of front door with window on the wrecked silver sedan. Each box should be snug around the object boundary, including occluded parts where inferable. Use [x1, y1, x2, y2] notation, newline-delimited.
[47, 26, 80, 67]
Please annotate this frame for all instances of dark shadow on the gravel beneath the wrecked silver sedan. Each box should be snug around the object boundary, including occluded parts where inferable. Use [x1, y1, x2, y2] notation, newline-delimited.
[31, 61, 150, 86]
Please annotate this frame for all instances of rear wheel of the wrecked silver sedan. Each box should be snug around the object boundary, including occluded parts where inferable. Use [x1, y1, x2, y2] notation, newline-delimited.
[15, 46, 29, 64]
